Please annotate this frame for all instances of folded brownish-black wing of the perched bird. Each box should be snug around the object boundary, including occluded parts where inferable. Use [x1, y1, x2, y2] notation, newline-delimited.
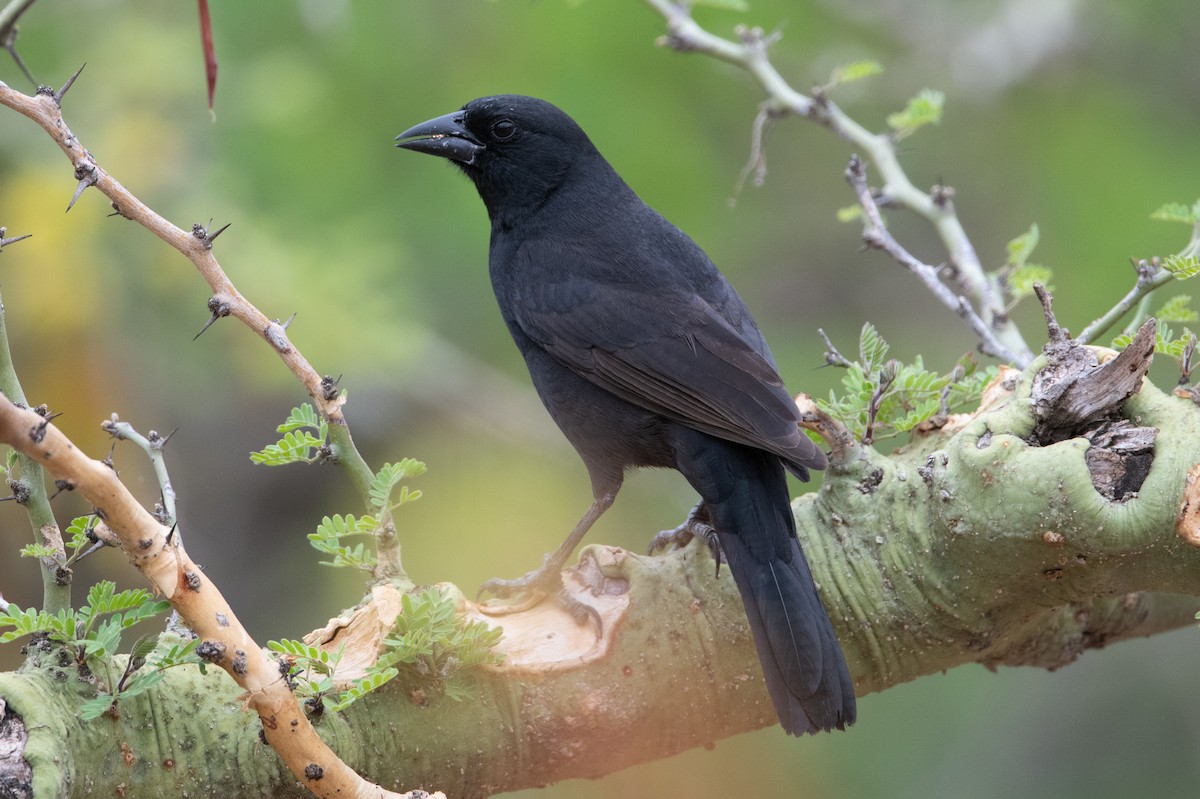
[514, 239, 823, 468]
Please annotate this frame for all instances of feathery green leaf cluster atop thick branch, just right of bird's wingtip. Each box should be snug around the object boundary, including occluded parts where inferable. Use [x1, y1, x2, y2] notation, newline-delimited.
[816, 323, 996, 441]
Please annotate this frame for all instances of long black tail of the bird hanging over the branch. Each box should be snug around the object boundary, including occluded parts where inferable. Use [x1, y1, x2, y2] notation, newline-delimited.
[680, 427, 856, 735]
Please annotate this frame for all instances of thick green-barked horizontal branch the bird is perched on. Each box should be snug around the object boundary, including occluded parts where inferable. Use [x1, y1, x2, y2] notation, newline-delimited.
[0, 356, 1200, 797]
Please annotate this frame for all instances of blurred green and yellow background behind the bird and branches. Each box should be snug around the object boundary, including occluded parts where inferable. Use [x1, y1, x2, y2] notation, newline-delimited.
[0, 0, 1200, 798]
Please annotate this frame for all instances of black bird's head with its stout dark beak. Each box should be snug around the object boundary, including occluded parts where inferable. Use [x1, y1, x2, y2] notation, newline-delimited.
[396, 95, 599, 220]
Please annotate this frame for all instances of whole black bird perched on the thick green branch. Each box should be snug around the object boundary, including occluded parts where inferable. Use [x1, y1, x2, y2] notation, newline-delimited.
[396, 95, 854, 735]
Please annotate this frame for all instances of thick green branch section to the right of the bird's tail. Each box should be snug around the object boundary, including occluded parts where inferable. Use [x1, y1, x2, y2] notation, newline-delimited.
[797, 358, 1200, 690]
